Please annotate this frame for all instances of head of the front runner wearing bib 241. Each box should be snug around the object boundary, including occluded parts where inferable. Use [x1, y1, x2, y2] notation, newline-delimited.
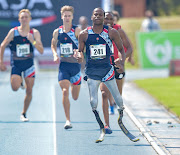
[91, 9, 104, 25]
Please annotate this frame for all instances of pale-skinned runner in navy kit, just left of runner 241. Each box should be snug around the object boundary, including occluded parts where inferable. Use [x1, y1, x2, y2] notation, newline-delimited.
[51, 6, 81, 129]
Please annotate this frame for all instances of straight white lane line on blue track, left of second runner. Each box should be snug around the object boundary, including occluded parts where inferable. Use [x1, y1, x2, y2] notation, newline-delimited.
[51, 86, 57, 155]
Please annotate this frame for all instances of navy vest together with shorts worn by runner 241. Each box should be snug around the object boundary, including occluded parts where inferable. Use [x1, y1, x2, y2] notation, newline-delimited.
[85, 25, 113, 81]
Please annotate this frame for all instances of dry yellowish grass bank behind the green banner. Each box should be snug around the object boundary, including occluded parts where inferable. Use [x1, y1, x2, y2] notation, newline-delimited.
[118, 16, 180, 68]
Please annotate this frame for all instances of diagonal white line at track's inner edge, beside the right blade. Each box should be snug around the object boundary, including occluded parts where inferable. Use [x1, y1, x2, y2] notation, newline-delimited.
[124, 105, 166, 155]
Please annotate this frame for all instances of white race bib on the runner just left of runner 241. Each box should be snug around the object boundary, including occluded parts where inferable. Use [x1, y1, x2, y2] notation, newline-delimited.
[60, 43, 73, 57]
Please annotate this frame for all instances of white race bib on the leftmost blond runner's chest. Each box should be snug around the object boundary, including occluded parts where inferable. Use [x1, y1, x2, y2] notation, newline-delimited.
[16, 44, 30, 57]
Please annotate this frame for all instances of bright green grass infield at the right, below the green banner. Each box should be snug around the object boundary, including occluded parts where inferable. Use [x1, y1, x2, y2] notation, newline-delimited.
[134, 77, 180, 117]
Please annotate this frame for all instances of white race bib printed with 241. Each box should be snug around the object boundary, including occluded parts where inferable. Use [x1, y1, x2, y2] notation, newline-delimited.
[90, 44, 106, 59]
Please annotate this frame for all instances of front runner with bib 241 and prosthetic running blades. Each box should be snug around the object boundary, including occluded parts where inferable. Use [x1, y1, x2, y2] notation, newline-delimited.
[77, 8, 125, 142]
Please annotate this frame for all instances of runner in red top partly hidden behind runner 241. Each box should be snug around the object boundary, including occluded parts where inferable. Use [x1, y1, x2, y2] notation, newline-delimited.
[100, 12, 132, 134]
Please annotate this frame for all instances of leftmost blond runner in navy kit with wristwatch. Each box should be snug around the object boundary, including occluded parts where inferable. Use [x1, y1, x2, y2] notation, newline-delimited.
[0, 9, 43, 122]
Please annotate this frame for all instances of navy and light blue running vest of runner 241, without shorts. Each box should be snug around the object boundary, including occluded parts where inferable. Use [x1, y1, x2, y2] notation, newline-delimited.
[85, 25, 112, 68]
